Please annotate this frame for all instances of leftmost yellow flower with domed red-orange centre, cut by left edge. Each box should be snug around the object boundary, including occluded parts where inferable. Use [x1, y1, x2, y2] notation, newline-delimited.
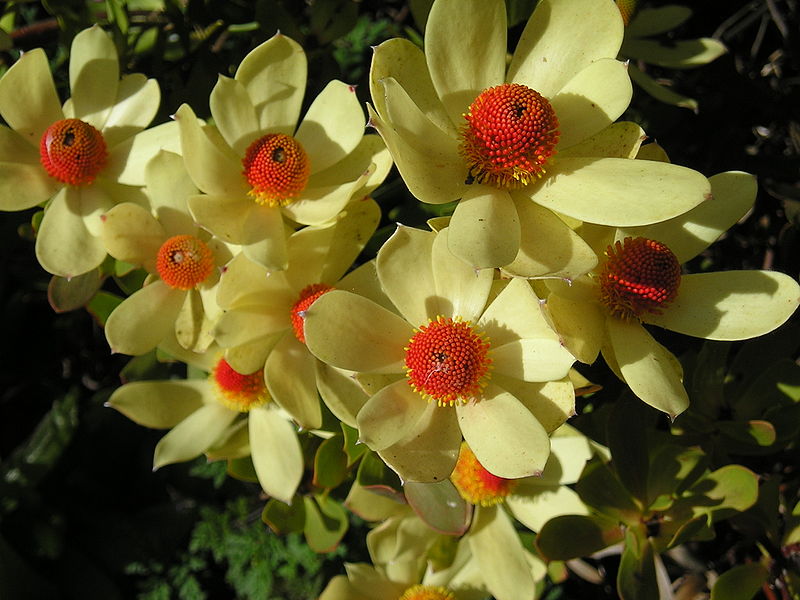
[0, 26, 177, 277]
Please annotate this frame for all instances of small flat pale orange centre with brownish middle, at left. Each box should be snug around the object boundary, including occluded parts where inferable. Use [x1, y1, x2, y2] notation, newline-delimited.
[156, 235, 214, 290]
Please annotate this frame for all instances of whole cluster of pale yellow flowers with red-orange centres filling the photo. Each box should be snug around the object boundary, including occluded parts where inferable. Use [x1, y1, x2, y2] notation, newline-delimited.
[0, 0, 800, 600]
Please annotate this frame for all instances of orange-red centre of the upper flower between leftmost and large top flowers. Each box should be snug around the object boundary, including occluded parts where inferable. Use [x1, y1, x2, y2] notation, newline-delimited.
[242, 133, 311, 206]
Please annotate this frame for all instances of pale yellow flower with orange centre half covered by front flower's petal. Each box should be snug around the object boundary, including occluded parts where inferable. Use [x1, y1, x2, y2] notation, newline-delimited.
[214, 198, 380, 429]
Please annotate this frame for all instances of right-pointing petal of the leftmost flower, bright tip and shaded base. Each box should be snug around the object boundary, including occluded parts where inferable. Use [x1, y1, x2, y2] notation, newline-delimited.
[103, 121, 181, 185]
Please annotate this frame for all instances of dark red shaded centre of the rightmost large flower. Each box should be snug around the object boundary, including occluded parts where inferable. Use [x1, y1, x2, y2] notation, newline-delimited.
[600, 237, 681, 321]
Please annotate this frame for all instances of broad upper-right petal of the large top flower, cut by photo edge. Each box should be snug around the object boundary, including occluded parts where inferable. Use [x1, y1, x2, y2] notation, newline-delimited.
[506, 0, 624, 98]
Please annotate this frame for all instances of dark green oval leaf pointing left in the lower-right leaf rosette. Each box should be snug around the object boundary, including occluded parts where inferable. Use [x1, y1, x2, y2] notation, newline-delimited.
[536, 515, 624, 560]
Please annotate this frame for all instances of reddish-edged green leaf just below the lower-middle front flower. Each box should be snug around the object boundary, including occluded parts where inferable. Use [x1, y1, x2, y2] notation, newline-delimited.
[403, 479, 472, 535]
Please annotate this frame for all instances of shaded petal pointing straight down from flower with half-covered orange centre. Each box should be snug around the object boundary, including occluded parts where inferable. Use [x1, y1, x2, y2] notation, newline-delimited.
[264, 332, 322, 429]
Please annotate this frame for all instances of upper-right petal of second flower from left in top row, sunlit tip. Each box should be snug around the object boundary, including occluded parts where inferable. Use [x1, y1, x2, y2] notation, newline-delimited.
[295, 80, 365, 173]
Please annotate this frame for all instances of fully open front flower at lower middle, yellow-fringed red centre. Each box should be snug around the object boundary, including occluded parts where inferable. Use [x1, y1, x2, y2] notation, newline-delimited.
[305, 226, 574, 481]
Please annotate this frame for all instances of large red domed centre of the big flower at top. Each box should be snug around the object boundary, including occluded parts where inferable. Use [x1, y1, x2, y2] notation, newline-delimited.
[459, 83, 559, 189]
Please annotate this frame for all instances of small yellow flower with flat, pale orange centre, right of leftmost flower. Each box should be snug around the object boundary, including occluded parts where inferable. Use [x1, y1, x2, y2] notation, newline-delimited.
[100, 151, 232, 355]
